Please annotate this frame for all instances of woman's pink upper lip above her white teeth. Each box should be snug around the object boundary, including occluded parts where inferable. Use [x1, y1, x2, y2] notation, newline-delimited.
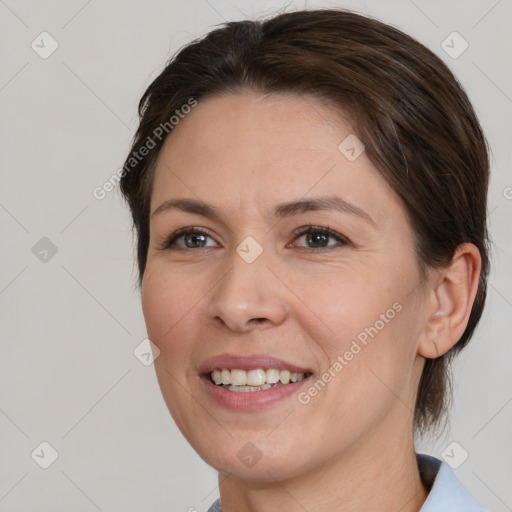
[198, 354, 312, 374]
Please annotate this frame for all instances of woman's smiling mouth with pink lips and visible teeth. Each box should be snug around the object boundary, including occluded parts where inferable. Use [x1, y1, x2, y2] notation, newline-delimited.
[198, 354, 313, 411]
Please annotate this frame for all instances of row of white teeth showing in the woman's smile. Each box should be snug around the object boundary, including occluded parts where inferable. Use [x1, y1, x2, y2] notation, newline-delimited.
[210, 368, 306, 392]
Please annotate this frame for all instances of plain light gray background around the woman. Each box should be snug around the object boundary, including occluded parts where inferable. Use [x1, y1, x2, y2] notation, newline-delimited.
[0, 0, 512, 512]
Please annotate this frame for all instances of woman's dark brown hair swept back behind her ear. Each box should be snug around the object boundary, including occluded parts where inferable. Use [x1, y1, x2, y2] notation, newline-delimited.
[121, 9, 489, 433]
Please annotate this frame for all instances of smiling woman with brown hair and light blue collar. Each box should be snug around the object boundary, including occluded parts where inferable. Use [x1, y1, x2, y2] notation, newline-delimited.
[121, 9, 489, 512]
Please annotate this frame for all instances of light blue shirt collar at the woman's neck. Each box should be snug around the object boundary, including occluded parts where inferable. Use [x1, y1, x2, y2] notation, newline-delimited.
[208, 454, 486, 512]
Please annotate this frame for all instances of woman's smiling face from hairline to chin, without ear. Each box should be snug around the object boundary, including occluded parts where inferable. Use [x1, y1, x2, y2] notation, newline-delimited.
[142, 92, 427, 480]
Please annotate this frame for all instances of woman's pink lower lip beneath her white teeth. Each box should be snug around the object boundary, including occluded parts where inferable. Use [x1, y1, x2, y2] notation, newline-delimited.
[201, 375, 312, 411]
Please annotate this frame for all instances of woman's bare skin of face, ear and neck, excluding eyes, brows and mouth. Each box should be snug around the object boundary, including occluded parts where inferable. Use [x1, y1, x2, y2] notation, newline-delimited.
[142, 91, 480, 512]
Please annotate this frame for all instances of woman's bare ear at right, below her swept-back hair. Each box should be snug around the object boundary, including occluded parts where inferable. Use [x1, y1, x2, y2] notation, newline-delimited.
[418, 243, 482, 359]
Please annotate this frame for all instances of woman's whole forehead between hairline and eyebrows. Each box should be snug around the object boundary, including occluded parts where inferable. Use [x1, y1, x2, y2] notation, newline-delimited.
[151, 92, 402, 225]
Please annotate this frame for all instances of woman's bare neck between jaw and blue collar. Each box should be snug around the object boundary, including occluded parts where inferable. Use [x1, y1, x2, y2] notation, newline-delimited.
[219, 420, 428, 512]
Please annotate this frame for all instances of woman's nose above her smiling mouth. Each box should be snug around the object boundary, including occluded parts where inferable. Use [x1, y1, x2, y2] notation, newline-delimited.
[208, 247, 288, 333]
